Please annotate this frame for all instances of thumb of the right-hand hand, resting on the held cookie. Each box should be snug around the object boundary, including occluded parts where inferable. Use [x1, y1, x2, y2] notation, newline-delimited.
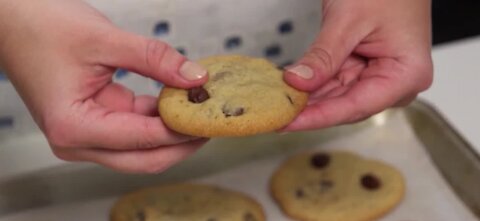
[284, 14, 362, 91]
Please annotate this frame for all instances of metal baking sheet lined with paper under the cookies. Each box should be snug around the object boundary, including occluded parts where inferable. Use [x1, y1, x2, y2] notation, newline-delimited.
[0, 101, 480, 221]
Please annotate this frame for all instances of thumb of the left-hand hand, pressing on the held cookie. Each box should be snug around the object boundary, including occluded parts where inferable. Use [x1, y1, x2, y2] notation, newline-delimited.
[103, 30, 207, 88]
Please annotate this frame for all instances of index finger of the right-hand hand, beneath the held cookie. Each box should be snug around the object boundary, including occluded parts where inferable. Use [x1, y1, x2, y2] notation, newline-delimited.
[284, 60, 413, 131]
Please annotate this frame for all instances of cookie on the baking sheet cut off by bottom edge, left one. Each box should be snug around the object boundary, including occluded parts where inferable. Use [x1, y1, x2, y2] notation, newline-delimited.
[110, 184, 265, 221]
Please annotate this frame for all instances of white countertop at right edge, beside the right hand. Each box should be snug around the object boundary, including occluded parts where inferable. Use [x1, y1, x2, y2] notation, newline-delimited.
[420, 38, 480, 152]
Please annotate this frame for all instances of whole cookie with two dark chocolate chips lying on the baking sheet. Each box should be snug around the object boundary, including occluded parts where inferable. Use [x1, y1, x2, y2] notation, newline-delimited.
[270, 152, 405, 221]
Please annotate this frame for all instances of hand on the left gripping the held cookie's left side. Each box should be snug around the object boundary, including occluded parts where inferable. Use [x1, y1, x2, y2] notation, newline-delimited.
[0, 0, 207, 173]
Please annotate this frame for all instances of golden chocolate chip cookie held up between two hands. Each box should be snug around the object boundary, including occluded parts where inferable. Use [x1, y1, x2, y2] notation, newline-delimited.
[158, 55, 308, 137]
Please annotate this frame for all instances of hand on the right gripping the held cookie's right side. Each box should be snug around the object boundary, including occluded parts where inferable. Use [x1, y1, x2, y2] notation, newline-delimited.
[284, 0, 432, 131]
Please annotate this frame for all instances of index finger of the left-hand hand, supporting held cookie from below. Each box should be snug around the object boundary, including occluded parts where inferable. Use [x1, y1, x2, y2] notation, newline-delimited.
[54, 101, 197, 150]
